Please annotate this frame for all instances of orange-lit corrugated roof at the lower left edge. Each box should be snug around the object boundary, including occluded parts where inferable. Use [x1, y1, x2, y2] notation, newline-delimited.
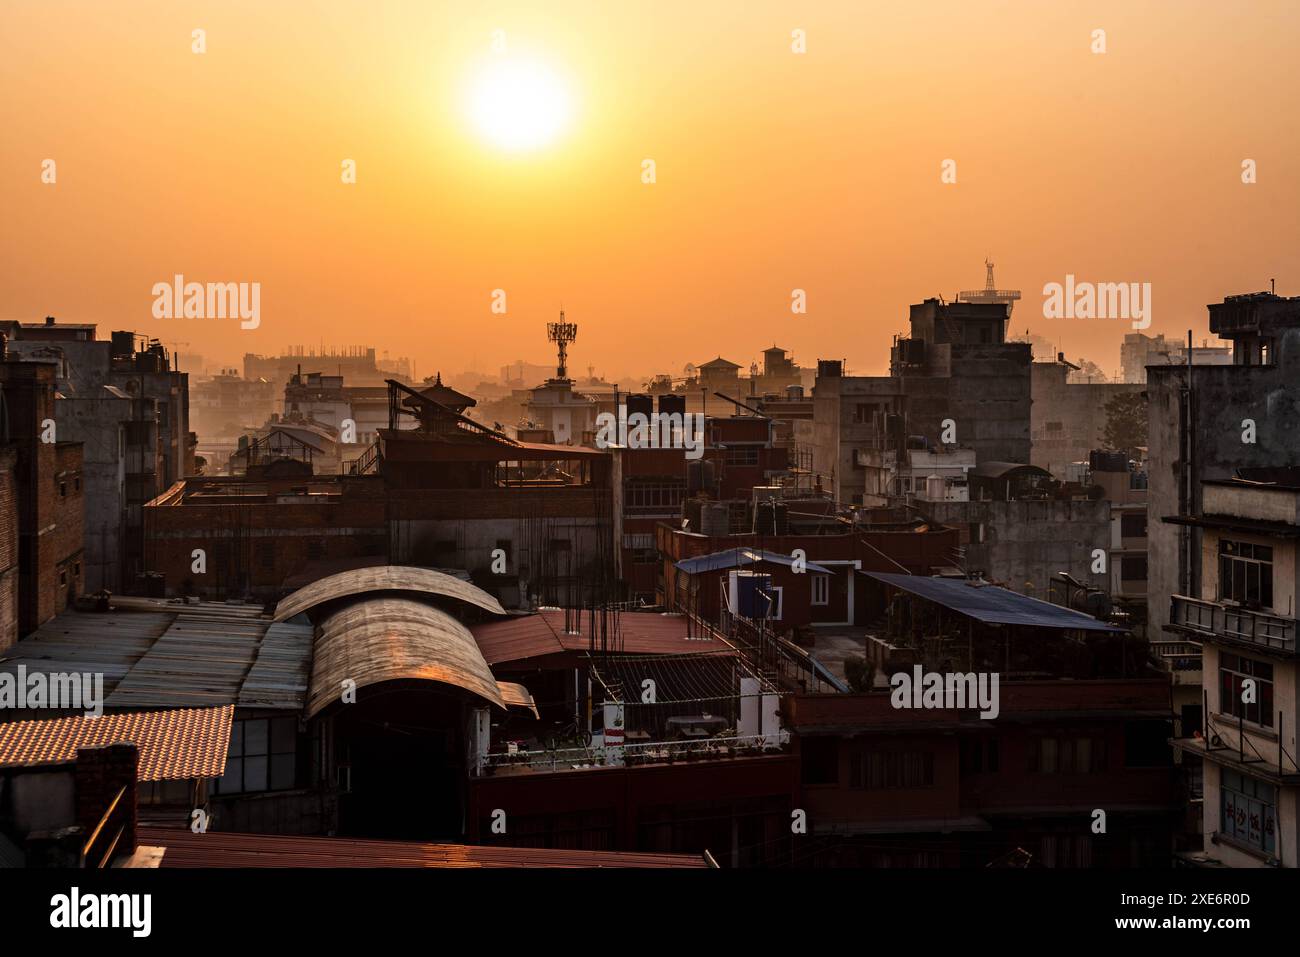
[0, 705, 235, 781]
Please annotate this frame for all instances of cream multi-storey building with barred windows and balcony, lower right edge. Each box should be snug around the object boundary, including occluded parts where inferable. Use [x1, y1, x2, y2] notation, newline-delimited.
[1162, 467, 1300, 867]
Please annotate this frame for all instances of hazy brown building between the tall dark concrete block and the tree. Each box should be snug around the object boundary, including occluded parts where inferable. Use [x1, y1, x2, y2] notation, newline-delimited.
[1028, 355, 1145, 480]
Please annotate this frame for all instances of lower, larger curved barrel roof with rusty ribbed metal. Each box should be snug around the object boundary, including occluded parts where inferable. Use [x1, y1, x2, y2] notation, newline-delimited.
[307, 597, 506, 718]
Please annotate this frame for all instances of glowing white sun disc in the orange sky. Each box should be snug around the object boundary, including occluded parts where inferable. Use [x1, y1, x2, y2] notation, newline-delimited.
[467, 59, 573, 152]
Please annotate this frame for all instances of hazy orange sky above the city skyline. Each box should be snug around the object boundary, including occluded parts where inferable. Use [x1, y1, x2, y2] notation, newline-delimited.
[0, 0, 1300, 376]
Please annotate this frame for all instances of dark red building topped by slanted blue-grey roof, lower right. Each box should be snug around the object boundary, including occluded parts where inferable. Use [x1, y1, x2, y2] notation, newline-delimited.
[787, 573, 1174, 869]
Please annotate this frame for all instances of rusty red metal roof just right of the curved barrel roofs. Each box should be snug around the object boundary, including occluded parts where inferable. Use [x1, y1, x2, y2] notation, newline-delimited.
[471, 609, 731, 664]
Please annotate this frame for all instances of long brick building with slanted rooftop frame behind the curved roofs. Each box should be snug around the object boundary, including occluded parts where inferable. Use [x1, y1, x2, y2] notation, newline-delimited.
[147, 380, 615, 607]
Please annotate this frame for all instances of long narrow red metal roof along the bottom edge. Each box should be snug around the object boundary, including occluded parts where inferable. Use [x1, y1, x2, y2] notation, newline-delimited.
[138, 827, 709, 867]
